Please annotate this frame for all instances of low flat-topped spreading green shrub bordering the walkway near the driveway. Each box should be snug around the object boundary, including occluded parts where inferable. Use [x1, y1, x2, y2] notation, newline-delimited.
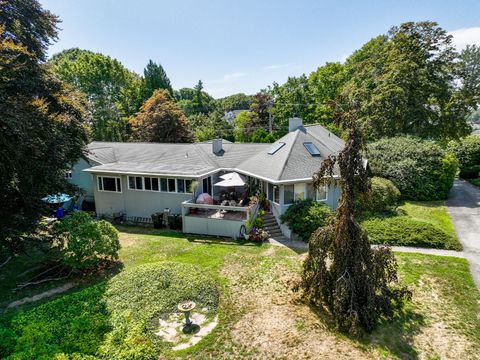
[361, 216, 461, 250]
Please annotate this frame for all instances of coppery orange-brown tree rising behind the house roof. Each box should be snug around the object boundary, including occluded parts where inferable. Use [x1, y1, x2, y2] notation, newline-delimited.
[130, 89, 194, 143]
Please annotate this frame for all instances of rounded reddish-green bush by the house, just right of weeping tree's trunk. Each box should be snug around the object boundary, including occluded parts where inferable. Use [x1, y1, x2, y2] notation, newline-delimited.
[358, 177, 401, 213]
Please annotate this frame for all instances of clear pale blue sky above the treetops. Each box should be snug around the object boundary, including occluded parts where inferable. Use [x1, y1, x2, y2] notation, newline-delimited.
[40, 0, 480, 97]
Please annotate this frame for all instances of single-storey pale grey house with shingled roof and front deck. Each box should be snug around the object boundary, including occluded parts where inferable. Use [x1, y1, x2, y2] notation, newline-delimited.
[71, 118, 344, 238]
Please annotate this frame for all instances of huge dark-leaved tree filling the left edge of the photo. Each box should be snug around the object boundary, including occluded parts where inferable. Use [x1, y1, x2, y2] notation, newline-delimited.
[0, 0, 88, 256]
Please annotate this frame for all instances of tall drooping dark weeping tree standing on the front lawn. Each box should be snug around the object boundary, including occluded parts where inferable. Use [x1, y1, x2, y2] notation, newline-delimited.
[301, 105, 411, 333]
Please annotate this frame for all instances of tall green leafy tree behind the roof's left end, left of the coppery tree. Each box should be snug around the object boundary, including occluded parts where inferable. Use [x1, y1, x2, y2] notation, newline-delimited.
[49, 49, 141, 141]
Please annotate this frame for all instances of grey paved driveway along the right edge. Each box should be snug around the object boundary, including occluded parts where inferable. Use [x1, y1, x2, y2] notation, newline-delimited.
[446, 180, 480, 288]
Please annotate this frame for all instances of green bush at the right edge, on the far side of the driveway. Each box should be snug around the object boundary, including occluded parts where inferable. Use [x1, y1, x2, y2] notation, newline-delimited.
[449, 135, 480, 179]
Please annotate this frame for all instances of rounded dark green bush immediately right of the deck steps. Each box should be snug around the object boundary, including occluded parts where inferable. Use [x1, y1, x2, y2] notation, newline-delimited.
[280, 199, 332, 241]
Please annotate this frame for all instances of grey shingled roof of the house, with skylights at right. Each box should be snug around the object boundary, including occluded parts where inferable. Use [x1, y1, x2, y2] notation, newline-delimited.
[86, 125, 344, 183]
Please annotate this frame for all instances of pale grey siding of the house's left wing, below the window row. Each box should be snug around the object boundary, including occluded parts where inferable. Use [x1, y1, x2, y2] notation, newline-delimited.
[94, 174, 192, 218]
